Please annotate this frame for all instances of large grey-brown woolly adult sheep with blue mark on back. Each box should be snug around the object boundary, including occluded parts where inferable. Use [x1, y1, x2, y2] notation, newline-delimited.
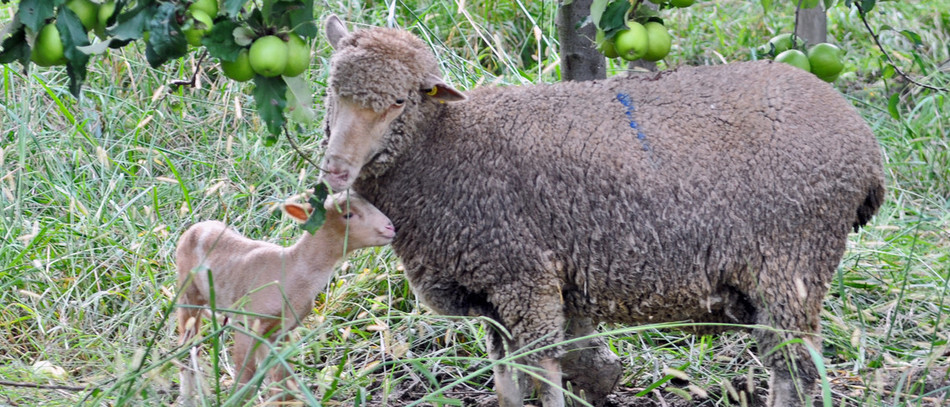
[322, 16, 884, 407]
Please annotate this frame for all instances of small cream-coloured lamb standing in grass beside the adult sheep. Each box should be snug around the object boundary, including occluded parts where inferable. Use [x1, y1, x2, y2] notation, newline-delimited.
[175, 193, 396, 405]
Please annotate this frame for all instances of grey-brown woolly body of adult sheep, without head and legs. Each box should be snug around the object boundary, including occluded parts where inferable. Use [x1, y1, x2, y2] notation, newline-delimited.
[357, 58, 882, 322]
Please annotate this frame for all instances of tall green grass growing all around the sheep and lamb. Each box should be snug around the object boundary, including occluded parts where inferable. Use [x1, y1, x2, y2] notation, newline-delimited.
[0, 0, 950, 406]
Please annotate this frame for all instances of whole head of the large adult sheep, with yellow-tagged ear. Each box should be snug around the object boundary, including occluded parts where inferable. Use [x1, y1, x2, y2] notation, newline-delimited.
[323, 16, 465, 191]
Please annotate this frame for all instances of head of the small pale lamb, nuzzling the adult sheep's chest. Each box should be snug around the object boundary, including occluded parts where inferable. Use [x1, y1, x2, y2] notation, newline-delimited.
[283, 191, 396, 251]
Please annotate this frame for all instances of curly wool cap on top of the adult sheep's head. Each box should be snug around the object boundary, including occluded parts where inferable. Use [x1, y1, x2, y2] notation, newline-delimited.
[329, 28, 441, 112]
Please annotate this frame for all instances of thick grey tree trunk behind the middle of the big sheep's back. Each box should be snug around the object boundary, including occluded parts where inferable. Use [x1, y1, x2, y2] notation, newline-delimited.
[557, 0, 607, 81]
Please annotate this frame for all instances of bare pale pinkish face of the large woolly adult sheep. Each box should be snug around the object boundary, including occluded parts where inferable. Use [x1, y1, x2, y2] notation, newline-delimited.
[323, 97, 406, 191]
